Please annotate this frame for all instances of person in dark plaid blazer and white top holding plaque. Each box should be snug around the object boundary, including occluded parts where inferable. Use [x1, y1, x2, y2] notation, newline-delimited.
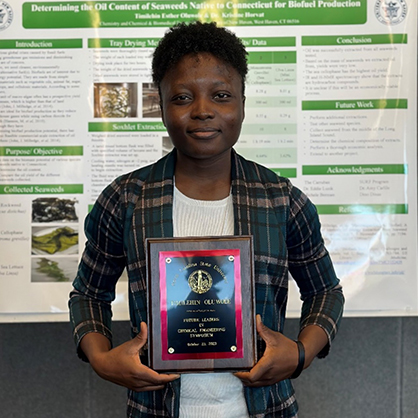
[70, 22, 344, 418]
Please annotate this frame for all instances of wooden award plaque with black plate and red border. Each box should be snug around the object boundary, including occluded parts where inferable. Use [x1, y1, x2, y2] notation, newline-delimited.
[146, 236, 257, 373]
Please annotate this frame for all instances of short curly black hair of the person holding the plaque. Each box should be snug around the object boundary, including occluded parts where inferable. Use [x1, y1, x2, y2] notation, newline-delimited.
[152, 21, 248, 94]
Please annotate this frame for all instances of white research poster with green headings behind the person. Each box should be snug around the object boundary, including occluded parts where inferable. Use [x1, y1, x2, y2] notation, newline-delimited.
[0, 0, 418, 322]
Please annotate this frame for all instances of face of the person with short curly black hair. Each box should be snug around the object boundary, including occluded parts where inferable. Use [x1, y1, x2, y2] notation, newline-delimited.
[160, 53, 245, 163]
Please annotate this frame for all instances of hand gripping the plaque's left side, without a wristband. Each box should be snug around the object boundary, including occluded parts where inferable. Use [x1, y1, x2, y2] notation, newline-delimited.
[80, 322, 180, 392]
